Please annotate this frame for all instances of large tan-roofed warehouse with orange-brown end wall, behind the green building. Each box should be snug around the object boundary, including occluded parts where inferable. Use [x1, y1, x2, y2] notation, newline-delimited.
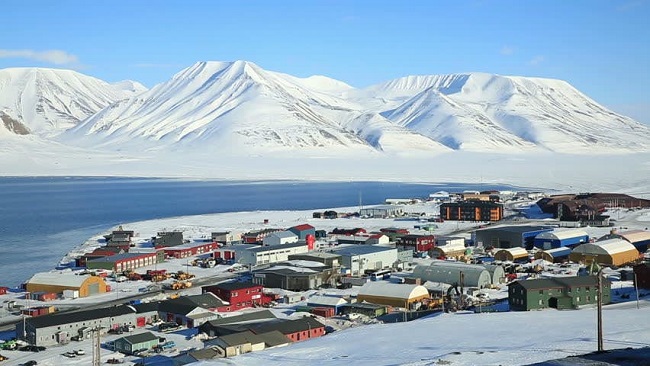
[569, 239, 639, 266]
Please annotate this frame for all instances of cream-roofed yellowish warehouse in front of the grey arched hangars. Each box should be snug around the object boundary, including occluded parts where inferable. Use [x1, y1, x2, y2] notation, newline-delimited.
[357, 281, 429, 310]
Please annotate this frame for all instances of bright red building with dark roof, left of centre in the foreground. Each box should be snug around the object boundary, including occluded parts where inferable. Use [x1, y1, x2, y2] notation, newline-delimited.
[201, 282, 272, 311]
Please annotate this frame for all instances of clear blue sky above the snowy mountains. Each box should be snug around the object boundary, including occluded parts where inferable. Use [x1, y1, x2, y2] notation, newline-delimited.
[0, 0, 650, 123]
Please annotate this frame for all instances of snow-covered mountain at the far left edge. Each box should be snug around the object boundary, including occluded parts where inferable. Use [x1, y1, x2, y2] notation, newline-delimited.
[0, 68, 138, 137]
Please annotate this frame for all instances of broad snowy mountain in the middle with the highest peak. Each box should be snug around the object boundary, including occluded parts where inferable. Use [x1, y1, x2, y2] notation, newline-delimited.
[61, 61, 447, 154]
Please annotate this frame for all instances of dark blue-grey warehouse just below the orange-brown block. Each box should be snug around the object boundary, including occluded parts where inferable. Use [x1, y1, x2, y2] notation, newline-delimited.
[472, 225, 553, 249]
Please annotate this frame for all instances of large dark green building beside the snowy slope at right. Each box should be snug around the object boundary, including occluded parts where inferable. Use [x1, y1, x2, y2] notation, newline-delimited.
[508, 276, 611, 311]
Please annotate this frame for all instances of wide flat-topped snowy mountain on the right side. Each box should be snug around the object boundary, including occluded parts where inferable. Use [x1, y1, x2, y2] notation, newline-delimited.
[368, 73, 650, 153]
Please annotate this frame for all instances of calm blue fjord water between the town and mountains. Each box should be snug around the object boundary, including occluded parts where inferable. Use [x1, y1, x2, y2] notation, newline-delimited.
[0, 177, 512, 287]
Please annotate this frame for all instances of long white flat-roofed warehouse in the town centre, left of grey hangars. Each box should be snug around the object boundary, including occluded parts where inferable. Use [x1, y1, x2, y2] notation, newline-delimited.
[334, 245, 397, 276]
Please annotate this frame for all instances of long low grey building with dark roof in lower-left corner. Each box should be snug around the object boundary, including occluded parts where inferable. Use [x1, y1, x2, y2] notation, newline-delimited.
[16, 305, 137, 346]
